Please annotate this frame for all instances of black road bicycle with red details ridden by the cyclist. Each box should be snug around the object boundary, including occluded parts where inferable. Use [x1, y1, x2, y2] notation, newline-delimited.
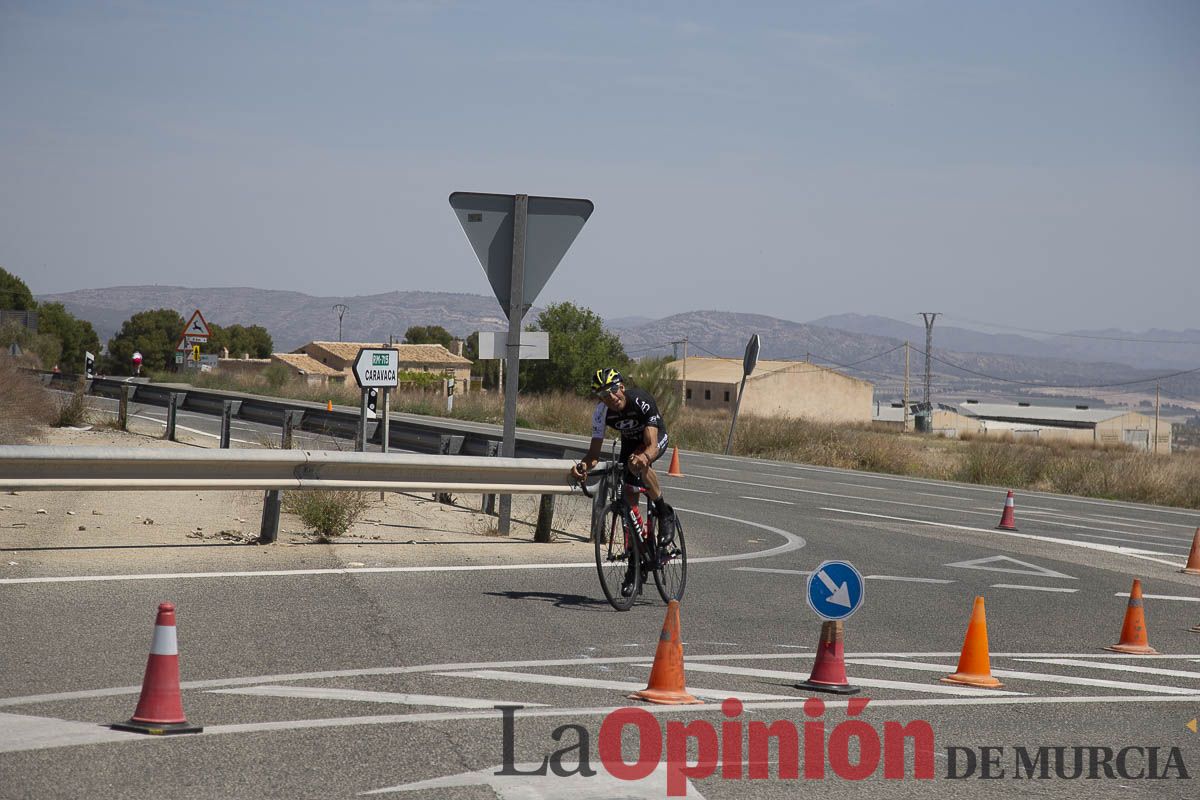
[580, 461, 688, 612]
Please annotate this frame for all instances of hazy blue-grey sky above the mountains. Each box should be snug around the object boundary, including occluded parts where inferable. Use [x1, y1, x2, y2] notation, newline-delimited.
[0, 0, 1200, 330]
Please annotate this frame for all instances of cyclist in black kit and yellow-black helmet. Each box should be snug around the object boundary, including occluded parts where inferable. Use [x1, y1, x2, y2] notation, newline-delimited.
[571, 367, 674, 590]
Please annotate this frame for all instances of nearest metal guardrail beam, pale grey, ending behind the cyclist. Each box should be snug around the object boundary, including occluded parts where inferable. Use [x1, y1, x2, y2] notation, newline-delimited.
[0, 445, 577, 494]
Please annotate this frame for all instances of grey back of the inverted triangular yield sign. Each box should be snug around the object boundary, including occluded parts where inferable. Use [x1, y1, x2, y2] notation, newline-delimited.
[450, 192, 594, 314]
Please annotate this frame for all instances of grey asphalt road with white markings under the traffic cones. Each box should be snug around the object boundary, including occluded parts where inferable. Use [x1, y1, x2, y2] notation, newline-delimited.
[0, 409, 1200, 800]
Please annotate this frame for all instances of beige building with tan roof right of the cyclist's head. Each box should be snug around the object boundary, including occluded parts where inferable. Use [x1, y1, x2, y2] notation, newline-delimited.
[667, 356, 875, 425]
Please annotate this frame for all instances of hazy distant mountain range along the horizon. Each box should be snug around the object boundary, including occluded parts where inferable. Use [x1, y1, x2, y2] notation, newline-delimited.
[38, 285, 1200, 398]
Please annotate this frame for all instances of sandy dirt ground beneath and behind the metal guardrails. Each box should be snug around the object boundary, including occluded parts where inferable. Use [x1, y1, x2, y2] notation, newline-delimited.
[0, 427, 592, 568]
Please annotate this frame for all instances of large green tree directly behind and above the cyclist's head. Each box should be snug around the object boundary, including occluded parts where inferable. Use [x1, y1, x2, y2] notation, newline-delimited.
[521, 302, 629, 395]
